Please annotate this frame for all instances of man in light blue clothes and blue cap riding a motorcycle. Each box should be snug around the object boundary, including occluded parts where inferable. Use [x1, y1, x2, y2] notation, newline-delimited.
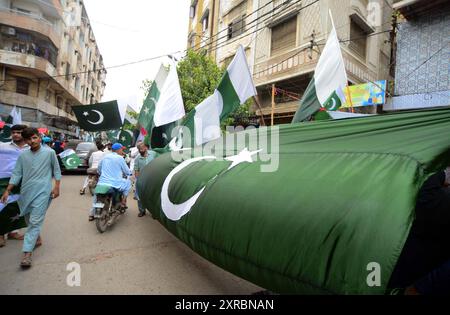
[98, 143, 131, 207]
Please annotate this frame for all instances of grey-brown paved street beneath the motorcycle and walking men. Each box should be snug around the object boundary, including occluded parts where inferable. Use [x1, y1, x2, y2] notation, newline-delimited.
[0, 176, 262, 295]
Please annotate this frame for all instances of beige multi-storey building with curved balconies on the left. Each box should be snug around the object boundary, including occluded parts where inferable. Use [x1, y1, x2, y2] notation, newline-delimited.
[0, 0, 106, 135]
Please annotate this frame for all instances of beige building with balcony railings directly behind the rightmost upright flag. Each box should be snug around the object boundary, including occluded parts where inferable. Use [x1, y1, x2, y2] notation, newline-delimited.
[253, 0, 392, 123]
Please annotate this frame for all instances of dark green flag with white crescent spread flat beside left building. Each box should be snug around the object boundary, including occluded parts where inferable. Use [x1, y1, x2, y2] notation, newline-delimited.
[72, 101, 122, 131]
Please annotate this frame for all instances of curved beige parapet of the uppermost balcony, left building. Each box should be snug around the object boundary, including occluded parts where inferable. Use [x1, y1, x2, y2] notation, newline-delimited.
[0, 7, 61, 49]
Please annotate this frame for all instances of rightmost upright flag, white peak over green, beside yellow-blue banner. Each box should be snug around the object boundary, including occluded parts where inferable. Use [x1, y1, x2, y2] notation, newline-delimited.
[292, 14, 348, 123]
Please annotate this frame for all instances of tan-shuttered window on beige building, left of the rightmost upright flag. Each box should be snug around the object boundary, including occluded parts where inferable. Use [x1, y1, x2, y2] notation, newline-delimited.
[270, 16, 297, 56]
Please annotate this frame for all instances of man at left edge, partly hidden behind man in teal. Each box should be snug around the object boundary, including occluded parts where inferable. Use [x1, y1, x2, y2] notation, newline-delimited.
[0, 125, 29, 247]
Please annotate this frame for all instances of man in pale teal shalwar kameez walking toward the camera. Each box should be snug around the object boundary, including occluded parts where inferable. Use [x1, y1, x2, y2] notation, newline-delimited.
[1, 128, 61, 268]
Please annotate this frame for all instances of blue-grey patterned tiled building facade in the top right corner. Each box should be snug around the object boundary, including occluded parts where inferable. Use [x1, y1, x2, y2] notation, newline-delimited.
[385, 0, 450, 111]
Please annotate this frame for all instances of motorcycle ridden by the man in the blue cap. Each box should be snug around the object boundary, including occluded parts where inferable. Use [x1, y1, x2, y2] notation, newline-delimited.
[94, 185, 127, 233]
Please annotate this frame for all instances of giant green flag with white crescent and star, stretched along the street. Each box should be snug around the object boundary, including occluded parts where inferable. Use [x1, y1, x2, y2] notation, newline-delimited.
[137, 108, 450, 294]
